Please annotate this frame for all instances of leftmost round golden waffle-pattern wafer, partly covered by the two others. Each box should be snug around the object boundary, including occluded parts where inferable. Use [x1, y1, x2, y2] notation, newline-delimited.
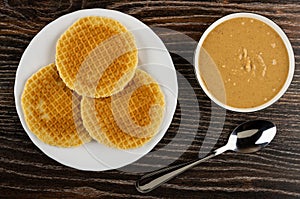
[21, 64, 91, 147]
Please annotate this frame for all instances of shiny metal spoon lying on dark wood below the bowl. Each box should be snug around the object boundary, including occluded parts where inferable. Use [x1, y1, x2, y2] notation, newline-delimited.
[136, 120, 276, 193]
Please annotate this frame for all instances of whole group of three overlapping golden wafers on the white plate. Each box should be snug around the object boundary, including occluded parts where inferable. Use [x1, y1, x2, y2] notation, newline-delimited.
[22, 16, 165, 149]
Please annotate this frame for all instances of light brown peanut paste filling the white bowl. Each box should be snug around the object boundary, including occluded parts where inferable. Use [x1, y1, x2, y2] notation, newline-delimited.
[199, 17, 289, 108]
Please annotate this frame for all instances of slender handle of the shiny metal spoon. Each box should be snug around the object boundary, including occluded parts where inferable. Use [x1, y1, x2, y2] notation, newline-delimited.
[135, 151, 220, 193]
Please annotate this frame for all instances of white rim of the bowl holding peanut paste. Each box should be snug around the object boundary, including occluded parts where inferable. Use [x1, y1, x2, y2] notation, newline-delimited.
[194, 12, 295, 112]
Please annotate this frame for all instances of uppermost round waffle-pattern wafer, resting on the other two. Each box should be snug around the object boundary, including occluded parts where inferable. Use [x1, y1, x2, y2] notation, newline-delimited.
[56, 16, 138, 98]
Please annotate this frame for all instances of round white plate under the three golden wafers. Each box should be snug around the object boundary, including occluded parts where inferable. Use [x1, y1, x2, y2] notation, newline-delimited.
[14, 9, 178, 171]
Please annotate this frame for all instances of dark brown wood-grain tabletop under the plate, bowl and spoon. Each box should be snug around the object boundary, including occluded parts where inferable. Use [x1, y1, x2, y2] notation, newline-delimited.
[0, 0, 300, 198]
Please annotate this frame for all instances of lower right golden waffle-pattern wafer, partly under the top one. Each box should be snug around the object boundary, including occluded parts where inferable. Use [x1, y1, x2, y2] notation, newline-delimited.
[81, 70, 165, 149]
